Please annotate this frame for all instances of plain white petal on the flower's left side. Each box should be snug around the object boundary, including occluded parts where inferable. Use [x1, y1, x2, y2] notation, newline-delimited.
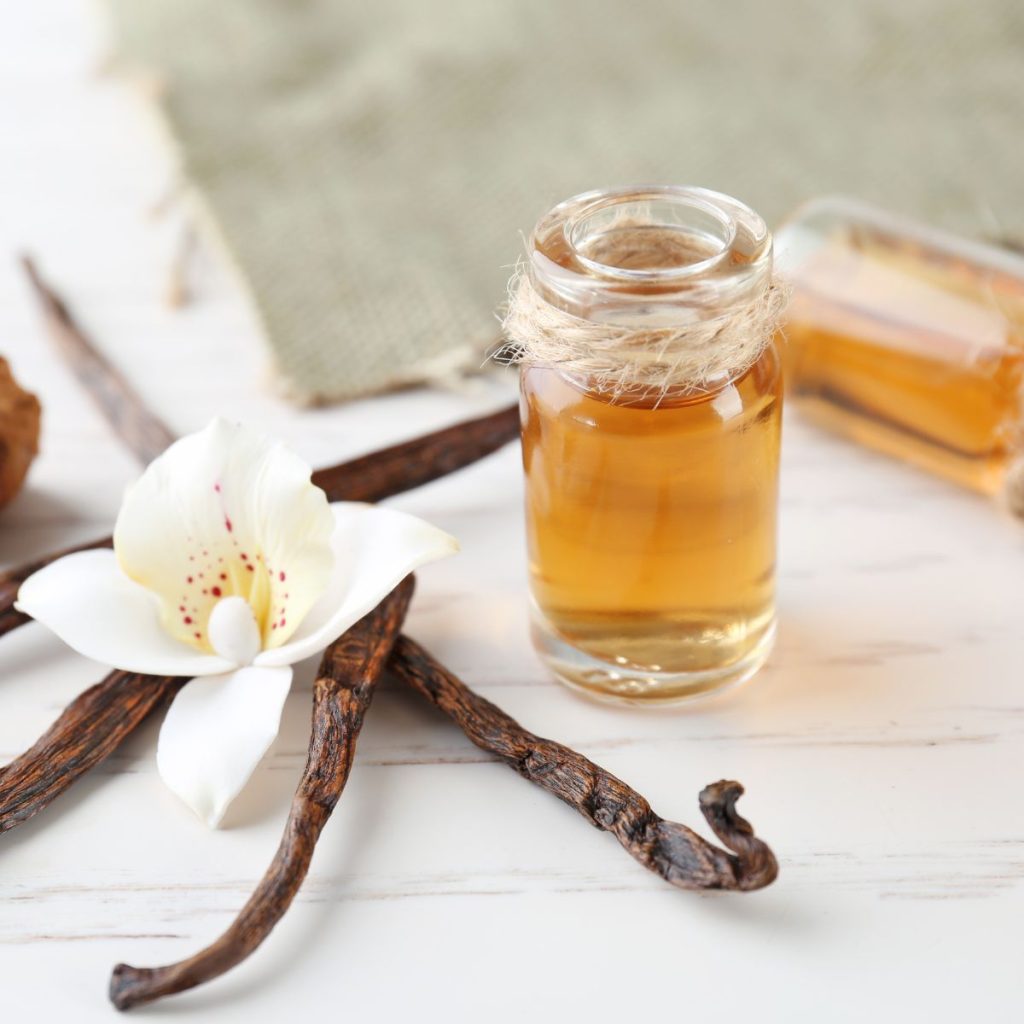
[15, 551, 233, 676]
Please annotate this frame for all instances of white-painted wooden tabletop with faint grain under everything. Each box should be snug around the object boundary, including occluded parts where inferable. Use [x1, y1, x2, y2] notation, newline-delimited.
[0, 0, 1024, 1024]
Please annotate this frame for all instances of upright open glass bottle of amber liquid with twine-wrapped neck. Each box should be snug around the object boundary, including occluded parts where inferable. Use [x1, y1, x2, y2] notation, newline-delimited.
[506, 186, 781, 703]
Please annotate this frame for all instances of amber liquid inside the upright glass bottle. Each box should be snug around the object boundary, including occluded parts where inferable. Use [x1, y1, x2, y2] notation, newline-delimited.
[522, 346, 781, 699]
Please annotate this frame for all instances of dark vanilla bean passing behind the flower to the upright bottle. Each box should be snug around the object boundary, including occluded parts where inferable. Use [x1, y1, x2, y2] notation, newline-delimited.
[0, 406, 519, 636]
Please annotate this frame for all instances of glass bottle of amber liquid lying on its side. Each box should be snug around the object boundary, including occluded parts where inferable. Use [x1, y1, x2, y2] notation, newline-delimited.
[776, 199, 1024, 494]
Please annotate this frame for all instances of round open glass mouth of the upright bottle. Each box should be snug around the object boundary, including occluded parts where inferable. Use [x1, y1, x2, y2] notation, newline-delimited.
[562, 187, 737, 283]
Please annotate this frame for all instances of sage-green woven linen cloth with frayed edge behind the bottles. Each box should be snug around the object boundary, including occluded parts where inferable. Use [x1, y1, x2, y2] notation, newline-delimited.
[111, 0, 1024, 401]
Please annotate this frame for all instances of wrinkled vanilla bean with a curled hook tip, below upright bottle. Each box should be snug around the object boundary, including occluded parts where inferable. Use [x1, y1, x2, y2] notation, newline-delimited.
[391, 636, 778, 891]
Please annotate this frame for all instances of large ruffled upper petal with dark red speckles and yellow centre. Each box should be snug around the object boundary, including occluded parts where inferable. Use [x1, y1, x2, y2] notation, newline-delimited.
[114, 420, 334, 651]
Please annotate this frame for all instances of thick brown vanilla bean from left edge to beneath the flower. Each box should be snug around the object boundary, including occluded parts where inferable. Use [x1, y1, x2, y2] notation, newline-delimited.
[0, 672, 185, 834]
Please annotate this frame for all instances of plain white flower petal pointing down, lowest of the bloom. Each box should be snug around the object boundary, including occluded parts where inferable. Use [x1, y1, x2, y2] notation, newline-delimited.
[157, 666, 292, 828]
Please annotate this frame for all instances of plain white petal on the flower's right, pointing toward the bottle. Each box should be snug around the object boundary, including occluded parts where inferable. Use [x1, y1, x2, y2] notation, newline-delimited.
[254, 502, 459, 665]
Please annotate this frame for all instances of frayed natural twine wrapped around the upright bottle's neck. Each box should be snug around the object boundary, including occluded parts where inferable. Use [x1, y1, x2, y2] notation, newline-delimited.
[502, 272, 787, 400]
